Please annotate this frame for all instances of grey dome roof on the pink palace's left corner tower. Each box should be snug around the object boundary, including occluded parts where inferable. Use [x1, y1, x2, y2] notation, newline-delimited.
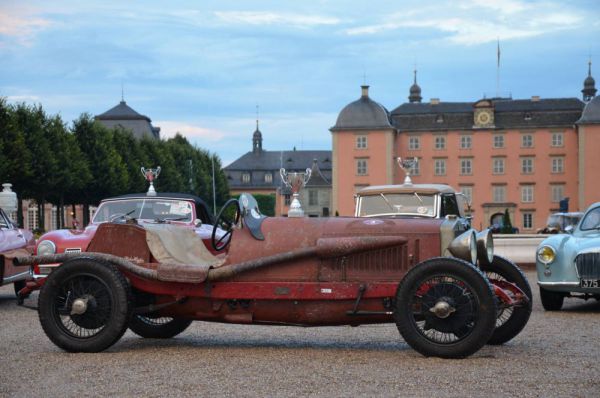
[331, 86, 393, 130]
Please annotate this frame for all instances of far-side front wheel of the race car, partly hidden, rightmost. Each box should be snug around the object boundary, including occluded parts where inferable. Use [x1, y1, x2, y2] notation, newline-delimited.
[481, 256, 532, 345]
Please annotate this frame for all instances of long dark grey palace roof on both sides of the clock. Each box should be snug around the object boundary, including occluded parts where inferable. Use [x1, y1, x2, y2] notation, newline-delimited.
[392, 98, 584, 131]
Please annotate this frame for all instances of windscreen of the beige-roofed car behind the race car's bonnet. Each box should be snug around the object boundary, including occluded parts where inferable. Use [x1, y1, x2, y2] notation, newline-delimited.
[359, 193, 435, 217]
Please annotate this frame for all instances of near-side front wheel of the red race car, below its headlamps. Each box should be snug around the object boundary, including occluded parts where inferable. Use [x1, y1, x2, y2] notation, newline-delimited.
[394, 257, 496, 358]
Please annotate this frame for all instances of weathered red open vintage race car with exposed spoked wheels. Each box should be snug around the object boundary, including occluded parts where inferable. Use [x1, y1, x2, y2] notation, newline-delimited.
[16, 194, 531, 358]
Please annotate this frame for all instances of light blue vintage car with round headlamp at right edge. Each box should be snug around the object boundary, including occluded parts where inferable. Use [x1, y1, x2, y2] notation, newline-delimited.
[536, 202, 600, 311]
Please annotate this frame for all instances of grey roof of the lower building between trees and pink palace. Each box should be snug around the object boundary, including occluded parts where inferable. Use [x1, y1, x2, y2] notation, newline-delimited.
[224, 150, 331, 171]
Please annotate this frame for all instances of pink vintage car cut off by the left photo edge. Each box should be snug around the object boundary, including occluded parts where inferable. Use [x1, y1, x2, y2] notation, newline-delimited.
[0, 209, 35, 294]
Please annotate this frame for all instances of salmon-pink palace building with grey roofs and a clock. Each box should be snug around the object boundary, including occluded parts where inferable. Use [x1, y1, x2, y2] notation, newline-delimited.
[330, 63, 600, 233]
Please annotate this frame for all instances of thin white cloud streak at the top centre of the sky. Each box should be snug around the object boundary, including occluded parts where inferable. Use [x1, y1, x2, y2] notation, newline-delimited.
[215, 11, 341, 28]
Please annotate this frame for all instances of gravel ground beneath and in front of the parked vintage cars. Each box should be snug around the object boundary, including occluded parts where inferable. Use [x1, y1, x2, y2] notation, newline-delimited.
[0, 271, 600, 397]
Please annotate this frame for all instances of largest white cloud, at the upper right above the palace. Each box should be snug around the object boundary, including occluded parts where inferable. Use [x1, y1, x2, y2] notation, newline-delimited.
[345, 0, 583, 45]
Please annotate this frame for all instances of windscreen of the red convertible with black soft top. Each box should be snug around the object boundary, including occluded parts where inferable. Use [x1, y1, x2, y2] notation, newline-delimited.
[93, 199, 193, 224]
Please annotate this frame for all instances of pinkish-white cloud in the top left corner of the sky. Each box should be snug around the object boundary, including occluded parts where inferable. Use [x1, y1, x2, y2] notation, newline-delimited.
[0, 5, 52, 45]
